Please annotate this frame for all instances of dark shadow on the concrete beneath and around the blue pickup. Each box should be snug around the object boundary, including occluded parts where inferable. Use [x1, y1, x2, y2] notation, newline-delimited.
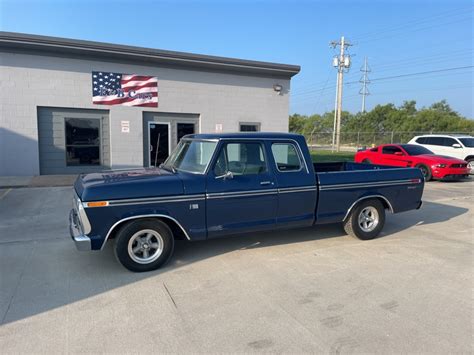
[0, 202, 468, 326]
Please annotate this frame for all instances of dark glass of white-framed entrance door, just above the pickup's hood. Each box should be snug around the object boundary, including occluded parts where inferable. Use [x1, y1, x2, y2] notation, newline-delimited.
[148, 122, 171, 167]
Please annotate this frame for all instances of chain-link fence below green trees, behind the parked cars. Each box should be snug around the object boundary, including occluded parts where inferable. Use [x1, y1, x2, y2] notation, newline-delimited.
[294, 131, 474, 151]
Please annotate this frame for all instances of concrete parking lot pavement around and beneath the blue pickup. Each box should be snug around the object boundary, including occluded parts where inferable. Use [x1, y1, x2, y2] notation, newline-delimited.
[0, 179, 474, 353]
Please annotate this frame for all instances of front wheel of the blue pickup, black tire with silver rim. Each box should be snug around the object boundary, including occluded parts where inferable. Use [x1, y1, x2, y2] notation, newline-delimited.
[114, 219, 174, 272]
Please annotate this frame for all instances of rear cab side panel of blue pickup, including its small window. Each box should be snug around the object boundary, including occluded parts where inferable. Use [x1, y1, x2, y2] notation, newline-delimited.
[268, 141, 318, 227]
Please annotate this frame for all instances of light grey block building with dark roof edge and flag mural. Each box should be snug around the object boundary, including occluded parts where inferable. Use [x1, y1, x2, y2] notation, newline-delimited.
[0, 32, 300, 176]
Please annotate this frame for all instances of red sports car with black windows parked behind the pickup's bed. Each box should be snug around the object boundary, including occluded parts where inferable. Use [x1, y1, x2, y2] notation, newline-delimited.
[354, 144, 469, 181]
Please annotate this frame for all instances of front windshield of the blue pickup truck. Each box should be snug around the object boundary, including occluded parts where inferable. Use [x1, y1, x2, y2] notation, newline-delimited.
[163, 139, 217, 174]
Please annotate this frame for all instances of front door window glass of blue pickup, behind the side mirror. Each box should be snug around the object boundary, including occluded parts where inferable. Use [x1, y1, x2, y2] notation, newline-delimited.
[214, 143, 267, 176]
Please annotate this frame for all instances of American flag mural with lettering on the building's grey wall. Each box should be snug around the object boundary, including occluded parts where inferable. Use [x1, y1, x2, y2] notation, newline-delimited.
[92, 71, 158, 107]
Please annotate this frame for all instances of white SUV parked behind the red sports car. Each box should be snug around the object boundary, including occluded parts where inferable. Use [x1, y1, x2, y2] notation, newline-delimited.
[408, 134, 474, 174]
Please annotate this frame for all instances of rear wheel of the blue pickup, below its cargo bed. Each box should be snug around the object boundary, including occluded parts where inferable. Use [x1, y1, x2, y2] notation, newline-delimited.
[344, 199, 385, 240]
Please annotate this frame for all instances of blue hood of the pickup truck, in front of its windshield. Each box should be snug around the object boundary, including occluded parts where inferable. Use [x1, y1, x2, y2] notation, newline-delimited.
[74, 168, 184, 201]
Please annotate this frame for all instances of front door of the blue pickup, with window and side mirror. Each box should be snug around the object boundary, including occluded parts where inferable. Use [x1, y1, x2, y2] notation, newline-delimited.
[206, 140, 278, 238]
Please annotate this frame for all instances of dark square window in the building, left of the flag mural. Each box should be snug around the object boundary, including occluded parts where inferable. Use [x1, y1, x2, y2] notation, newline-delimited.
[65, 118, 101, 166]
